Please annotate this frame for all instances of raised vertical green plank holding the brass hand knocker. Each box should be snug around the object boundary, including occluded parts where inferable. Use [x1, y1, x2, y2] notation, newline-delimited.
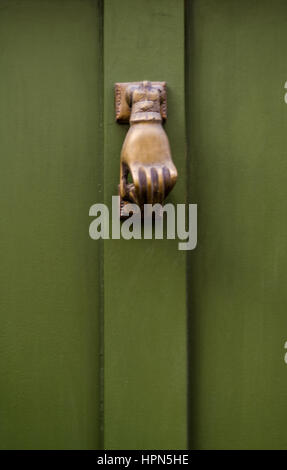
[104, 0, 187, 449]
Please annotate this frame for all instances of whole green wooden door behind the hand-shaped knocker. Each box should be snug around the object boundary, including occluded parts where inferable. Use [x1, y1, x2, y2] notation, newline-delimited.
[0, 0, 287, 449]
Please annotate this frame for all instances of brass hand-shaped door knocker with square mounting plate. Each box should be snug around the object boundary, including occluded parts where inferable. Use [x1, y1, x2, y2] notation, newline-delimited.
[115, 81, 177, 216]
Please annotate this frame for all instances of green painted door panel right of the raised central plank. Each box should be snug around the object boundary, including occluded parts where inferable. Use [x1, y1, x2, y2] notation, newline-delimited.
[187, 0, 287, 449]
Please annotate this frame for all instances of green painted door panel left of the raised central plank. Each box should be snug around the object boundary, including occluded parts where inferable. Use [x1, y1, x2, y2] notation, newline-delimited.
[0, 0, 101, 449]
